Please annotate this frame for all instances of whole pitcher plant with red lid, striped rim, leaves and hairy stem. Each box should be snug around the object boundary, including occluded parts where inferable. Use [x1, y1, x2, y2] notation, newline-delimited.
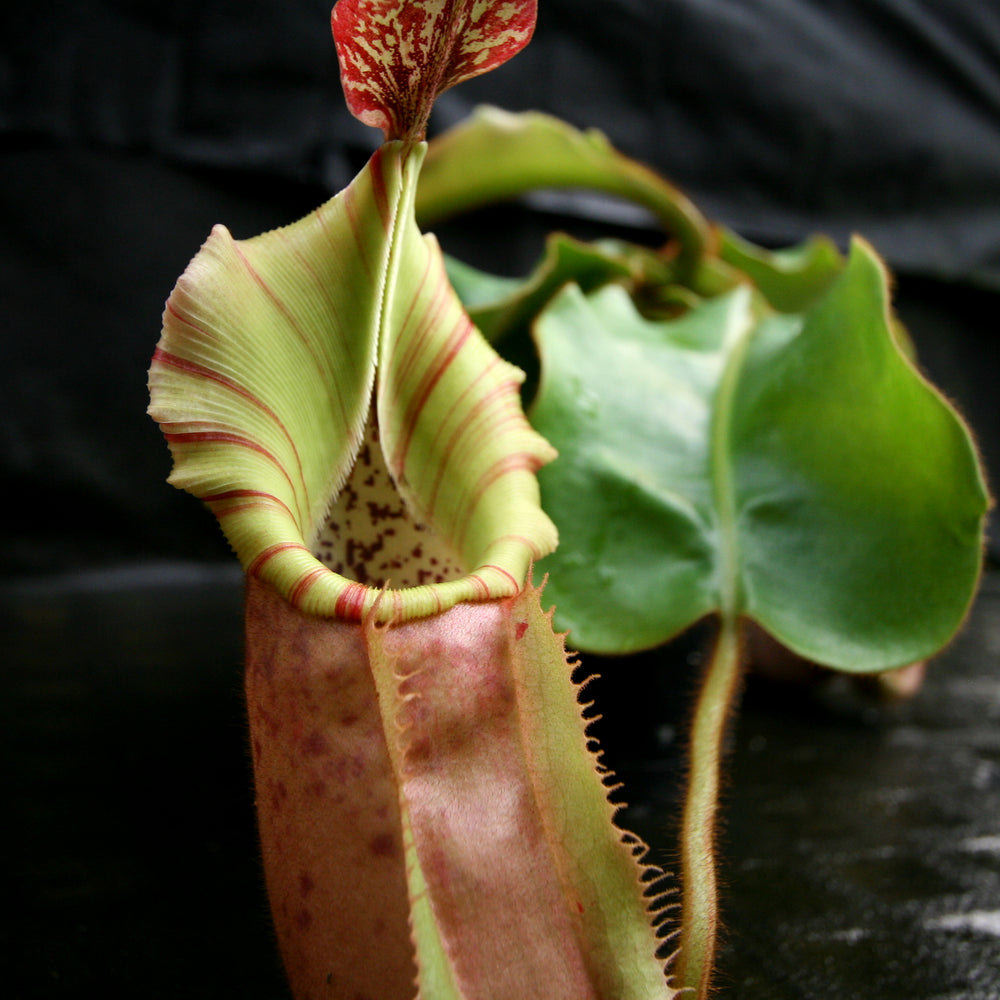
[149, 0, 987, 1000]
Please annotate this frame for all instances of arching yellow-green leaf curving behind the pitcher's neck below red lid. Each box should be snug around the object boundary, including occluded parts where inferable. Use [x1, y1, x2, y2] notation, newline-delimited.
[416, 106, 709, 270]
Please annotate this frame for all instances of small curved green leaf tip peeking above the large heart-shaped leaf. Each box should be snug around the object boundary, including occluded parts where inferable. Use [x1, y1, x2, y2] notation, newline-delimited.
[717, 227, 844, 312]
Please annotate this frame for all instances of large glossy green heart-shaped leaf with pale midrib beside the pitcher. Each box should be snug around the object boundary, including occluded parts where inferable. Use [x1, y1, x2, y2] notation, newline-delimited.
[531, 241, 987, 671]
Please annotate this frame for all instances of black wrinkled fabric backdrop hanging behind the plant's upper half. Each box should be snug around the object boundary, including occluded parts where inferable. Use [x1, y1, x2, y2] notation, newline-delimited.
[0, 0, 1000, 573]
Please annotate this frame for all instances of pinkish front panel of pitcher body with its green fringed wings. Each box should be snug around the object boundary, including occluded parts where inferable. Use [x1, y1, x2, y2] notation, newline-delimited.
[365, 587, 675, 1000]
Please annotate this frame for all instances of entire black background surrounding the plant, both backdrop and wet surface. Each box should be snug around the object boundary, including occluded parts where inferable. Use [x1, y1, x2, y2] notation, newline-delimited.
[0, 0, 1000, 1000]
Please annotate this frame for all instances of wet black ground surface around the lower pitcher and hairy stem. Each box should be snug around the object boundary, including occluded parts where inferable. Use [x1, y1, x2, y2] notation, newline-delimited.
[0, 566, 1000, 1000]
